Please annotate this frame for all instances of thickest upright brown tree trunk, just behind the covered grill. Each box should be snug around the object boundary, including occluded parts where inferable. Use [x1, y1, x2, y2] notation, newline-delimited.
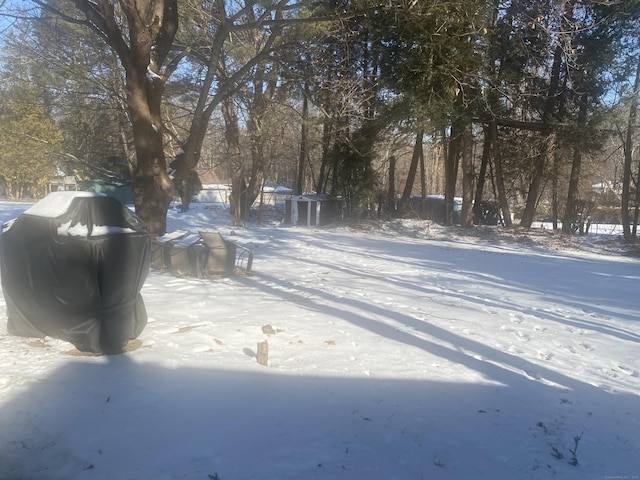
[67, 0, 178, 237]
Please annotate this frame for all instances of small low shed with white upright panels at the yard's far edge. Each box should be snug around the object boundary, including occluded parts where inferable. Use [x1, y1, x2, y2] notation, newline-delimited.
[284, 195, 342, 227]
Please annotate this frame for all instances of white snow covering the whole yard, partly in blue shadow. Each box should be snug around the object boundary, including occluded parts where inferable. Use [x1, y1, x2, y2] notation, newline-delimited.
[0, 203, 640, 480]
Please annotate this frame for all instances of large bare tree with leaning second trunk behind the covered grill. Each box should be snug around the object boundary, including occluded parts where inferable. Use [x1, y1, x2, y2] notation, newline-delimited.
[32, 0, 316, 232]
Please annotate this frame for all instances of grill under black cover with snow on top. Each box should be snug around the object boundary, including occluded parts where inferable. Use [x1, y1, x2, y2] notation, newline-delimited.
[0, 192, 151, 353]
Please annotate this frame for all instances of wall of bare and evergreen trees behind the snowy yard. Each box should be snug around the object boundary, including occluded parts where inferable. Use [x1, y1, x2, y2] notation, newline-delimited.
[0, 0, 640, 238]
